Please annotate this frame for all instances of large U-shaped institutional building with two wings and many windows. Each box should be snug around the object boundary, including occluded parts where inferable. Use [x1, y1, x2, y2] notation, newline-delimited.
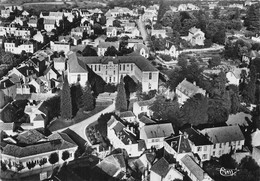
[67, 53, 159, 92]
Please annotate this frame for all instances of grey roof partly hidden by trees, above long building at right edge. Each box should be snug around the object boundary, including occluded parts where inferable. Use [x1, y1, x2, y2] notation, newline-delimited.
[226, 112, 252, 126]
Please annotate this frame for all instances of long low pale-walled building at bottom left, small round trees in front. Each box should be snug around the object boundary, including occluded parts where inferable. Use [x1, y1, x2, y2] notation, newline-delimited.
[1, 129, 78, 172]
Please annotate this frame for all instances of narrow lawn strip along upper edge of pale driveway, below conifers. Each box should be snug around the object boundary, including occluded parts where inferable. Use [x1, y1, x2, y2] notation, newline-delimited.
[48, 101, 112, 131]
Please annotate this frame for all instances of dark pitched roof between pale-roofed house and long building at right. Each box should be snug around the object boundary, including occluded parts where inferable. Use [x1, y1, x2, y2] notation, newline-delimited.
[182, 127, 212, 146]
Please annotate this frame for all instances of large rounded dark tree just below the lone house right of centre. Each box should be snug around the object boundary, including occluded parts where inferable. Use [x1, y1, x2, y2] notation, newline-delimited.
[180, 94, 208, 125]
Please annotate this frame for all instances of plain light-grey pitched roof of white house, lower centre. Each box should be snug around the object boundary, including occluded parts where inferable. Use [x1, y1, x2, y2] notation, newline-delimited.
[140, 123, 174, 139]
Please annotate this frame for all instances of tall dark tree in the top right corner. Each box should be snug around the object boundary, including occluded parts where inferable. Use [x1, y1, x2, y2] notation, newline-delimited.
[244, 3, 260, 32]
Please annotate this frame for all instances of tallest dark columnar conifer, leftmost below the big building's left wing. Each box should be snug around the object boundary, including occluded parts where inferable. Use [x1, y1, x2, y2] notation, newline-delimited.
[60, 75, 72, 119]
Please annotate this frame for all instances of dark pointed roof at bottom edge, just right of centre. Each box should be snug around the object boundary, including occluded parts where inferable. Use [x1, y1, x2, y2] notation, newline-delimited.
[150, 157, 170, 178]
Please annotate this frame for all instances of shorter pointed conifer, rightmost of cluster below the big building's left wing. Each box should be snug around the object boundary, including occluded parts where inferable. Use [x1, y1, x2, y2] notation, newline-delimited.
[82, 82, 95, 111]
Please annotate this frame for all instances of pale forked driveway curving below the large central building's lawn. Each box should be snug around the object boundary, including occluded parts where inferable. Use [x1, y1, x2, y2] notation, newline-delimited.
[55, 102, 115, 145]
